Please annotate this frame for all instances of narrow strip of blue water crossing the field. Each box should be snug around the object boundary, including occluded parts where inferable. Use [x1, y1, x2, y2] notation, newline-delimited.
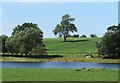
[0, 62, 120, 69]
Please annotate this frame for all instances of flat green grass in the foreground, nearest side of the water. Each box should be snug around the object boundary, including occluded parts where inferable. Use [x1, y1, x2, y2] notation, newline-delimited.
[2, 68, 118, 81]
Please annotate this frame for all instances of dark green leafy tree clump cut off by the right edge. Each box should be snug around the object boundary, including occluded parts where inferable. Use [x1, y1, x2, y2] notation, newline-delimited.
[96, 25, 120, 58]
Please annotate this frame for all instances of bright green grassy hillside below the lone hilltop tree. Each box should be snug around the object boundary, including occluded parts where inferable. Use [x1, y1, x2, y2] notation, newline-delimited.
[43, 38, 100, 54]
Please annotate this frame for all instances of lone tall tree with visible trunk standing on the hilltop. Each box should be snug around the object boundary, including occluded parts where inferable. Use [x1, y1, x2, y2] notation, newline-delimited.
[53, 14, 77, 42]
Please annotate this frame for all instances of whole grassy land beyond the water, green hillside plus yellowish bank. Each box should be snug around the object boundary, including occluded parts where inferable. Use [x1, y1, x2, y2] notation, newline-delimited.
[0, 37, 119, 63]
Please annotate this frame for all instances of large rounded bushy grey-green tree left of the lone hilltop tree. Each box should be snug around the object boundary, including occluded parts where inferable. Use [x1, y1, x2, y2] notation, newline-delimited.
[6, 23, 45, 55]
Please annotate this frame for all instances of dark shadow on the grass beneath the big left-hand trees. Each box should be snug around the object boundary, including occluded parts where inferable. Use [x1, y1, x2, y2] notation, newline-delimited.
[2, 55, 63, 59]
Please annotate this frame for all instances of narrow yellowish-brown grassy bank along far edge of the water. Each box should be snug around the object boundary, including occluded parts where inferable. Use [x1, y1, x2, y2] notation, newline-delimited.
[1, 56, 120, 63]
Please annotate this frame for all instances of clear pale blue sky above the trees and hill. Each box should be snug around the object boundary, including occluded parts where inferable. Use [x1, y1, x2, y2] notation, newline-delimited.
[0, 0, 118, 38]
